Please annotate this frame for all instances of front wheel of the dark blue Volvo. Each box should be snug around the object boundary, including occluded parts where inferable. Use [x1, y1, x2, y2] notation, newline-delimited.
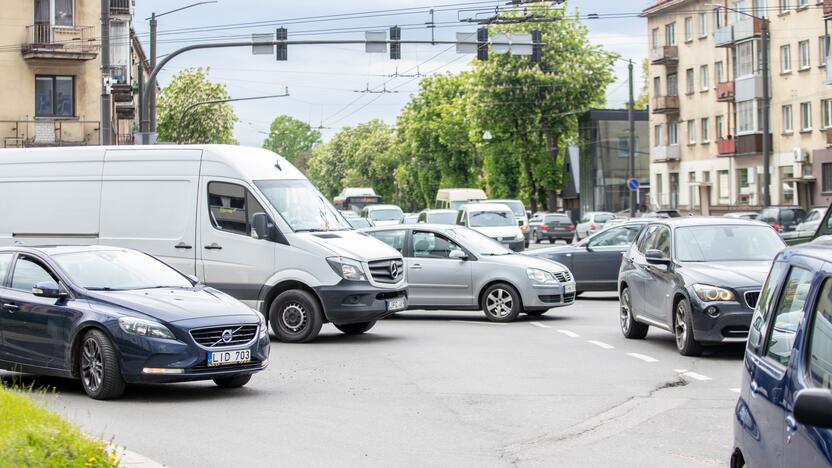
[78, 330, 126, 400]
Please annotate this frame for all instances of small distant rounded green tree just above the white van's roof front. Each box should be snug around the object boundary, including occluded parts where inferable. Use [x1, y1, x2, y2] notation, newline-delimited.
[263, 115, 321, 172]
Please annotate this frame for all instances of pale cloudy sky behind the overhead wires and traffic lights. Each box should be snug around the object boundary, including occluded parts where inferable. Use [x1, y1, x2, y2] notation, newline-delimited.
[134, 0, 654, 146]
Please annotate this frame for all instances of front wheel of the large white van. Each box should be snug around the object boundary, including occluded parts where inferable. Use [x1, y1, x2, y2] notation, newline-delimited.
[269, 289, 324, 343]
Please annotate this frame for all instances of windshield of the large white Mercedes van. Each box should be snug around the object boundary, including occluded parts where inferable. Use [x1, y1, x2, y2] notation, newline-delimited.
[254, 180, 350, 232]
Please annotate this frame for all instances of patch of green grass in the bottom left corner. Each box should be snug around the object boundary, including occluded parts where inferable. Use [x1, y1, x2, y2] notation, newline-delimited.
[0, 385, 118, 468]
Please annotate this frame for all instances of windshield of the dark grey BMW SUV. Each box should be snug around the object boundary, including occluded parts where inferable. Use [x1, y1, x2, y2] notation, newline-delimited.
[676, 225, 785, 262]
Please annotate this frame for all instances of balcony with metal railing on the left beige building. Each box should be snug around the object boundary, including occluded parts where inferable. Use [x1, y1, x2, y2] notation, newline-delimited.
[20, 24, 98, 61]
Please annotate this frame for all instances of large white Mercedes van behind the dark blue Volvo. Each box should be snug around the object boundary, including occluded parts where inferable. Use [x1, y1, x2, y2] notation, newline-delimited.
[0, 145, 407, 342]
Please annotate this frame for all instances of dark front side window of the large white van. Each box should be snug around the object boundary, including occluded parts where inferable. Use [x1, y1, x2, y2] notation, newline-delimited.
[208, 182, 266, 236]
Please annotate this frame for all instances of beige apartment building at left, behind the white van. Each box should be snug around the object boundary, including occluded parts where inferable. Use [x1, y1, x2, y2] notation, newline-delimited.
[0, 0, 146, 147]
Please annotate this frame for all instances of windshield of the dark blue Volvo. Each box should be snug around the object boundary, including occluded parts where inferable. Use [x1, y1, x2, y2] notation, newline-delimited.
[53, 250, 193, 291]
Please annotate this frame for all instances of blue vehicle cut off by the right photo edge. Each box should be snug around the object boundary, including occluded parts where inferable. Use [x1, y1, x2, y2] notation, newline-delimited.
[731, 241, 832, 468]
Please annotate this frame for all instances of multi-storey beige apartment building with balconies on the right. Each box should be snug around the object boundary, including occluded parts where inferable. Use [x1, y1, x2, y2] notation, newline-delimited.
[642, 0, 832, 214]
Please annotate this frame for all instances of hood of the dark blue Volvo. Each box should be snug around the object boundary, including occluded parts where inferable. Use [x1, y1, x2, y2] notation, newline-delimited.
[89, 286, 257, 323]
